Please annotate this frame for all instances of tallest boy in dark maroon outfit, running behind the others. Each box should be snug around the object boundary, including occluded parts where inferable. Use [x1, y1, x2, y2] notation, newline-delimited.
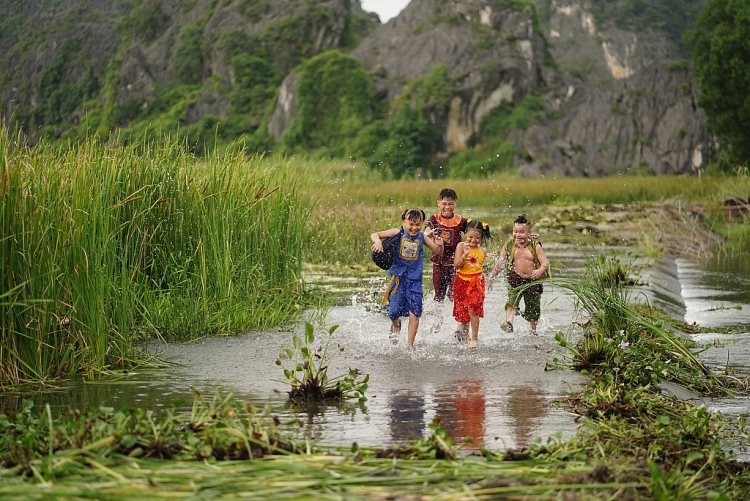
[427, 188, 466, 332]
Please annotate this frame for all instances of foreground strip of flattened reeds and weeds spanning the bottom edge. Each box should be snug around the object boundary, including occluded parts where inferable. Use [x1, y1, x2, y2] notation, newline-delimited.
[0, 391, 750, 501]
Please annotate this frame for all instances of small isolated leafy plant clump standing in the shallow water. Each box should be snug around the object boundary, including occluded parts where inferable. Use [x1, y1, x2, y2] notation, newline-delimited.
[276, 322, 370, 402]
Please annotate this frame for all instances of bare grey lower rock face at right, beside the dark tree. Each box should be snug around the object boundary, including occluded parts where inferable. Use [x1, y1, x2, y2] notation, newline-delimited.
[512, 66, 713, 177]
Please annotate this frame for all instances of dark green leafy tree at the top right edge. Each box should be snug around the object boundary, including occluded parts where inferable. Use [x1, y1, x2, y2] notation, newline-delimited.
[686, 0, 750, 163]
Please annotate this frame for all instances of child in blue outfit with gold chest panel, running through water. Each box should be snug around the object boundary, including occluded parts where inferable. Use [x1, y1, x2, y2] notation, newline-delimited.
[370, 208, 443, 347]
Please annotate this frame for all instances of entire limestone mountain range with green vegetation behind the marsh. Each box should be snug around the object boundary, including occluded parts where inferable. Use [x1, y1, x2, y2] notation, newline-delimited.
[0, 0, 712, 177]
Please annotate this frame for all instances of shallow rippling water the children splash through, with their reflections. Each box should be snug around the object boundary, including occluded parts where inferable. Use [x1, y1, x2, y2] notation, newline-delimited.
[2, 249, 750, 450]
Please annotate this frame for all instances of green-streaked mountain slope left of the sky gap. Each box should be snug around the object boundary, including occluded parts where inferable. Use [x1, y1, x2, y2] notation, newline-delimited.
[0, 0, 379, 150]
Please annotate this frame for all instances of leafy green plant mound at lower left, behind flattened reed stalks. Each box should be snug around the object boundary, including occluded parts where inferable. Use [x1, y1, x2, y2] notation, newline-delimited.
[0, 392, 300, 481]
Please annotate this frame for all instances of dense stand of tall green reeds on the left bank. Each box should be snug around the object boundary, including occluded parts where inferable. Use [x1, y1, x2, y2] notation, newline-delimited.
[0, 130, 314, 385]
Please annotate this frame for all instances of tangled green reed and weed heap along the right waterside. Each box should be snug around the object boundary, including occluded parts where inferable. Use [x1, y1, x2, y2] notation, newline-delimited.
[532, 252, 750, 499]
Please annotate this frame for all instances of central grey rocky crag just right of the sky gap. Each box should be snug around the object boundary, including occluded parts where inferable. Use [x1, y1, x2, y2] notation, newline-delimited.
[352, 0, 551, 151]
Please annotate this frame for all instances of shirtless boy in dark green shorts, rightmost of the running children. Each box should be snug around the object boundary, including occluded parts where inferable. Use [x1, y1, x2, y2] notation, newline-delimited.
[490, 214, 549, 336]
